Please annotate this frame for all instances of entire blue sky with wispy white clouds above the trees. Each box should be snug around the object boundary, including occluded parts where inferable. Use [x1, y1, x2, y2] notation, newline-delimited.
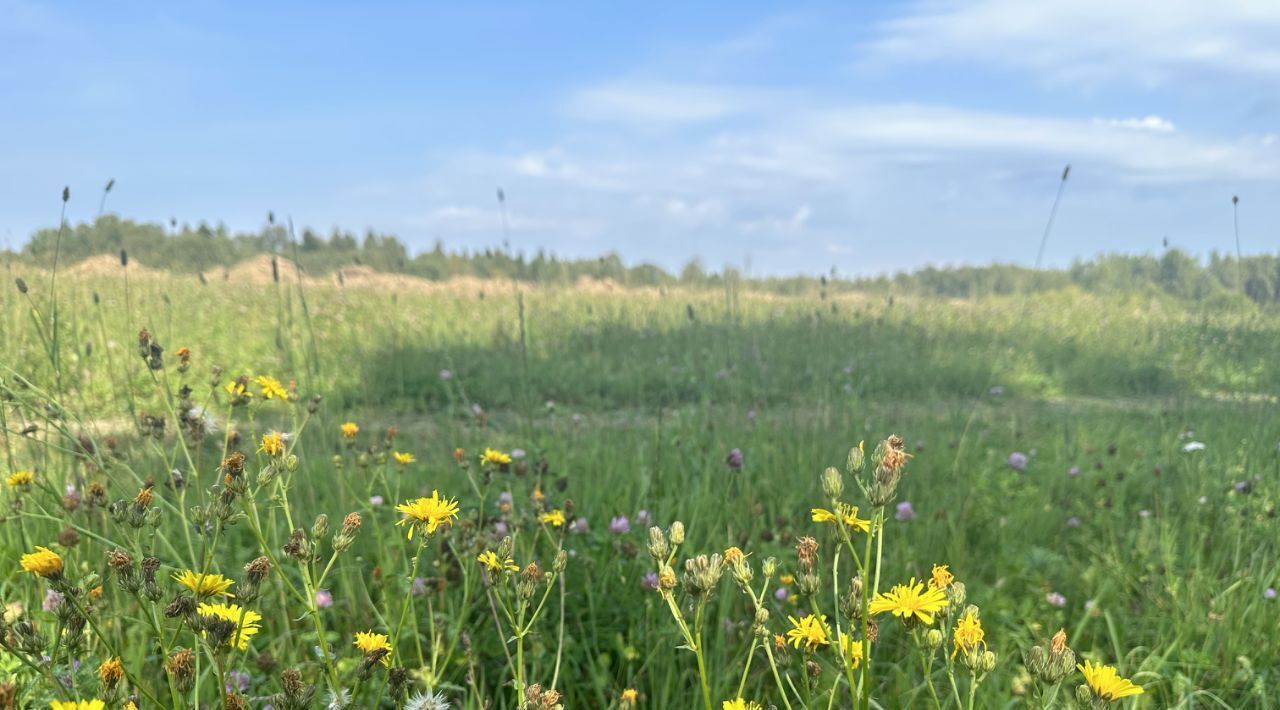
[0, 0, 1280, 274]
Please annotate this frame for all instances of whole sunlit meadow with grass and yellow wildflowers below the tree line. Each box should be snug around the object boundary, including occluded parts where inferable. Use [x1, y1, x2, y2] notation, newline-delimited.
[0, 258, 1280, 710]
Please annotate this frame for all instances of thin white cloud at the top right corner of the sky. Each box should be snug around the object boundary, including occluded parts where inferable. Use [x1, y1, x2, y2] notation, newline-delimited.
[867, 0, 1280, 86]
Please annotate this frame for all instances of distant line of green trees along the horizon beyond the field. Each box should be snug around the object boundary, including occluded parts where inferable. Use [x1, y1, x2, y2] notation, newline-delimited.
[10, 215, 1280, 304]
